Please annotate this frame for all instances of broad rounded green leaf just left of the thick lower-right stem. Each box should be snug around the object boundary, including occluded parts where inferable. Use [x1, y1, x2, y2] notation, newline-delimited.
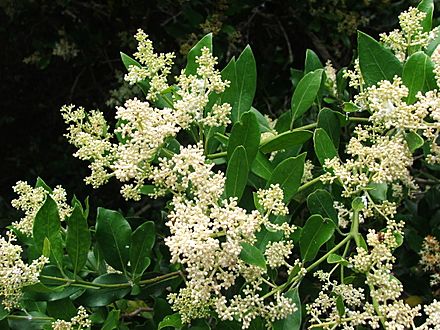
[299, 214, 335, 262]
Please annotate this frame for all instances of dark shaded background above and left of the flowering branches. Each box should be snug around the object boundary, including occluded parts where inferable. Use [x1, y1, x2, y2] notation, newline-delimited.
[0, 0, 420, 227]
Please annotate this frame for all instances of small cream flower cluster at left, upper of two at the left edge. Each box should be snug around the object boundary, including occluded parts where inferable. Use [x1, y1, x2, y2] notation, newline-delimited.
[11, 181, 72, 236]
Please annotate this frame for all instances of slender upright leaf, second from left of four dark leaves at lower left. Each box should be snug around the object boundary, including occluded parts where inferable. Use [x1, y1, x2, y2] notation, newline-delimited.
[66, 206, 92, 274]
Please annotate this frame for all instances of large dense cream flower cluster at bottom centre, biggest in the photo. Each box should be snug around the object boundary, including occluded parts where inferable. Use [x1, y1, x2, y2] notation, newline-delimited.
[149, 146, 295, 328]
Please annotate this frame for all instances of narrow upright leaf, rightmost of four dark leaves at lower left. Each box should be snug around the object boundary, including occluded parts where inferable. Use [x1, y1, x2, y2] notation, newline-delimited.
[130, 221, 156, 279]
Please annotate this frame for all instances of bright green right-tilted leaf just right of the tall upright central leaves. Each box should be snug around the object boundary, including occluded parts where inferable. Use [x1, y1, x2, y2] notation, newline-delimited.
[290, 69, 323, 128]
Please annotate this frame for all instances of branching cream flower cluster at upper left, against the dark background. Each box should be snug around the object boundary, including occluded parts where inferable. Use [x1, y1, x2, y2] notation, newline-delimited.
[61, 34, 231, 200]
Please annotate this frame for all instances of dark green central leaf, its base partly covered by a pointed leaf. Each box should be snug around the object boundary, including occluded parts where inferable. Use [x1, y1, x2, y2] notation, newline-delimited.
[227, 111, 260, 164]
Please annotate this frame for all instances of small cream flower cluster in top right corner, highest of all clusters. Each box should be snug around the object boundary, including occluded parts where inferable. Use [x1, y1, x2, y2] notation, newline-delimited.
[380, 7, 438, 62]
